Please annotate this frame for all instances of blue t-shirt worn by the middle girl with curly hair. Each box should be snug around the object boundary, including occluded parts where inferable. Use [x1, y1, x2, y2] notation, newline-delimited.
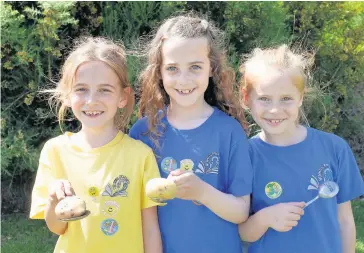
[130, 108, 253, 253]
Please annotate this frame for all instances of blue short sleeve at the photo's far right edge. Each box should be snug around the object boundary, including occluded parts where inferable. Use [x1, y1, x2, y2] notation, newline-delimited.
[337, 141, 364, 204]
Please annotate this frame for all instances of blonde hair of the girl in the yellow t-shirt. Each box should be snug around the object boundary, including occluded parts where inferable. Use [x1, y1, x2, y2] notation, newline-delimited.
[48, 37, 135, 130]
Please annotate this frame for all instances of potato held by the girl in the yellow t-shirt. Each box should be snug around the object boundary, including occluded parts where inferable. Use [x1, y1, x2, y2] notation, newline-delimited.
[55, 196, 86, 219]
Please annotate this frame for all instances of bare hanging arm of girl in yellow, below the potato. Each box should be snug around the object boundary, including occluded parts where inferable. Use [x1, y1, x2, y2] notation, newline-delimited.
[142, 206, 162, 253]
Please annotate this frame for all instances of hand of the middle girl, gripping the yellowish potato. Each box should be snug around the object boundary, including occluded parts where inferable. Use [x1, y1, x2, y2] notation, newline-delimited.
[168, 169, 206, 201]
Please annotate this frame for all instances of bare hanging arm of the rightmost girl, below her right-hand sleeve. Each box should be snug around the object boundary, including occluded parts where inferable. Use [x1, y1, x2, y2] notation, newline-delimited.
[338, 201, 356, 253]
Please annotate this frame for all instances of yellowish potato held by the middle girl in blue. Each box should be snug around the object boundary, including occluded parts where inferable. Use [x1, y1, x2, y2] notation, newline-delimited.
[145, 178, 177, 202]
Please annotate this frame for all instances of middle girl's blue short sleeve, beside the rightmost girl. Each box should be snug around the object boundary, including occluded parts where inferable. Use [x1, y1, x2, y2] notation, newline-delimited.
[228, 130, 253, 197]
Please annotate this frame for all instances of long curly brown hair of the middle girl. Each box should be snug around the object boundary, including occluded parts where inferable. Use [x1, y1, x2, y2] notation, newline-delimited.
[139, 14, 246, 142]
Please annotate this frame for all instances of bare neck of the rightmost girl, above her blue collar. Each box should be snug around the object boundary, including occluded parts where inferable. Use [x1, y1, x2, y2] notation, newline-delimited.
[260, 125, 307, 146]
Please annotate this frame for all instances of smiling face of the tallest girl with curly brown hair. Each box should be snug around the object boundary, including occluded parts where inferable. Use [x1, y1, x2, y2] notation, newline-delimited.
[161, 37, 211, 107]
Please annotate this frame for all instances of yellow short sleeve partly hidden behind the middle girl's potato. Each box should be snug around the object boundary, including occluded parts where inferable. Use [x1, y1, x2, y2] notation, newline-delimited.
[141, 151, 161, 209]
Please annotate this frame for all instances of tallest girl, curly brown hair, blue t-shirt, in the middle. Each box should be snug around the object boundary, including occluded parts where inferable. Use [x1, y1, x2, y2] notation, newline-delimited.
[130, 16, 252, 253]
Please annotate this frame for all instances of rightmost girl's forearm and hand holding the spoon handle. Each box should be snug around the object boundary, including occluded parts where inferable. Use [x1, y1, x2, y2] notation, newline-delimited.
[239, 202, 305, 242]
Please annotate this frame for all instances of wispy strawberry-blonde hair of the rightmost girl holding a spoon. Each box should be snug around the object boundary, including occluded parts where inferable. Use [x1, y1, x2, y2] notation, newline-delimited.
[239, 44, 316, 124]
